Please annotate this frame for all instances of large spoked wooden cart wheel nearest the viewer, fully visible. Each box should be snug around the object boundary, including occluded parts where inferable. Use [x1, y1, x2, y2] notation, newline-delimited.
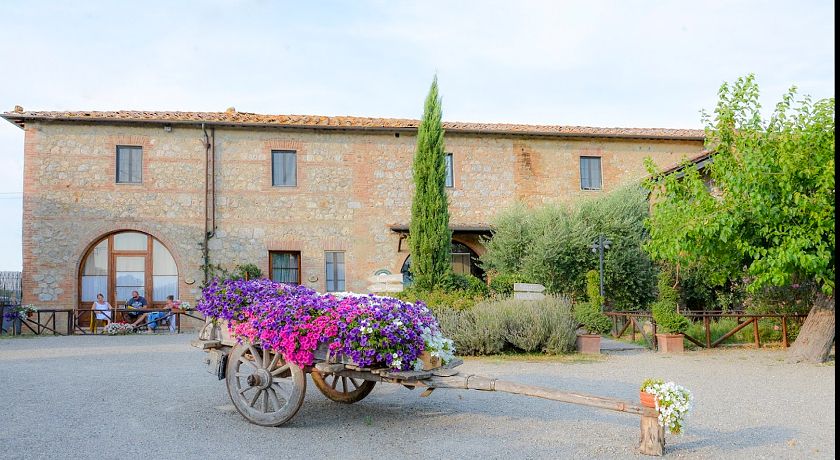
[226, 342, 306, 426]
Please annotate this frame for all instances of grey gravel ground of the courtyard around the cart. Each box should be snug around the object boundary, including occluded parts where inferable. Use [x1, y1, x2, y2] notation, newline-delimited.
[0, 334, 835, 459]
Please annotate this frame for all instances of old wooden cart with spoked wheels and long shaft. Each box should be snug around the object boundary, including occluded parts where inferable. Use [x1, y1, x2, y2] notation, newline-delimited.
[192, 322, 665, 455]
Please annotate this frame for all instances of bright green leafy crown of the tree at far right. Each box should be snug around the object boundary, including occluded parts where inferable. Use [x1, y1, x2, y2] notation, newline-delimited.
[646, 75, 835, 294]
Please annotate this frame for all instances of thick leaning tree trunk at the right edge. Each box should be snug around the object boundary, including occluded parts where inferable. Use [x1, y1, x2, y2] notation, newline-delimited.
[787, 292, 834, 363]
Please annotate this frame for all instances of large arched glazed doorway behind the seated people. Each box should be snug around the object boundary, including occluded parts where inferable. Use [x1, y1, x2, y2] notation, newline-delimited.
[78, 231, 178, 307]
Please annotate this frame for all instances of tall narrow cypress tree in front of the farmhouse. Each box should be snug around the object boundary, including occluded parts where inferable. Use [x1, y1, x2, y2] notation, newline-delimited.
[409, 75, 452, 290]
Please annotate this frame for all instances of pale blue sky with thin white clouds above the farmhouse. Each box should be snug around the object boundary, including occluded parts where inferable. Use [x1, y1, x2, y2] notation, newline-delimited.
[0, 0, 835, 270]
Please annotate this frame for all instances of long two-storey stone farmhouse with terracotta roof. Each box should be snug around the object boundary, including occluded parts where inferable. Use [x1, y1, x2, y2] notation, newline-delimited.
[2, 107, 703, 316]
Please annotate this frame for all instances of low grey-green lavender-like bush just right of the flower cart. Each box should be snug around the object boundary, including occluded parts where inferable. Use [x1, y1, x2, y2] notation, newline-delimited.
[437, 296, 577, 355]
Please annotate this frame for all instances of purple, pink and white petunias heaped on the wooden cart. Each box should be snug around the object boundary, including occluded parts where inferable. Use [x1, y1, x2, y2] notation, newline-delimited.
[196, 279, 455, 371]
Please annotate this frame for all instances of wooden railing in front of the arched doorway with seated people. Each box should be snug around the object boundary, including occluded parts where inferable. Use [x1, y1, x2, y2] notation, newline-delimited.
[0, 308, 204, 335]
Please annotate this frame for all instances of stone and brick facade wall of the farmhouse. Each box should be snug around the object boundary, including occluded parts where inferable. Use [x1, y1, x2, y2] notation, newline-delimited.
[23, 122, 702, 318]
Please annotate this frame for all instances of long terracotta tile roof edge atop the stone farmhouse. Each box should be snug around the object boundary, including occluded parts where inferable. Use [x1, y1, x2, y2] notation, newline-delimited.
[2, 106, 703, 140]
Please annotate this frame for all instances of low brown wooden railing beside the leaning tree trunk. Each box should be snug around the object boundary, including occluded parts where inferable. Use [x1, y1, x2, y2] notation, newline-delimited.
[606, 311, 807, 350]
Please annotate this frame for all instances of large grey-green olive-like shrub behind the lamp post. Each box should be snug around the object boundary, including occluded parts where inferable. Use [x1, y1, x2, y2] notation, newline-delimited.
[481, 186, 656, 310]
